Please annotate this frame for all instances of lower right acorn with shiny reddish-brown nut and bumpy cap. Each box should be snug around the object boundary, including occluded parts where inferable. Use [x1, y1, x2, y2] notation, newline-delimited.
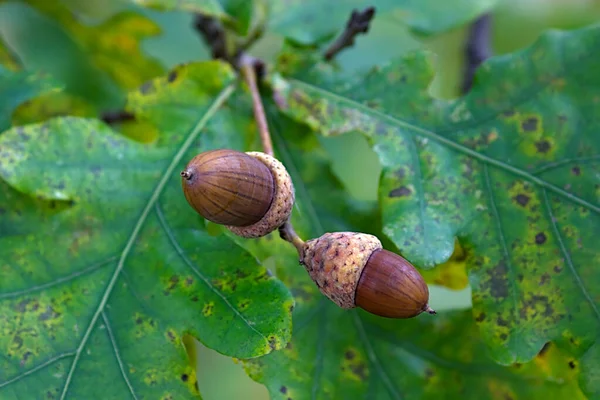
[300, 232, 435, 318]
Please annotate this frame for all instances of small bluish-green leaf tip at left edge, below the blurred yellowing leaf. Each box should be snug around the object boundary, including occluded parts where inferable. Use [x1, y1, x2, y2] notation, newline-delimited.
[0, 66, 59, 132]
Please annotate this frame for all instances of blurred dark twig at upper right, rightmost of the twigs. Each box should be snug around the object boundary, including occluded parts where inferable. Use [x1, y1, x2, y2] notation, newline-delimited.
[462, 14, 492, 93]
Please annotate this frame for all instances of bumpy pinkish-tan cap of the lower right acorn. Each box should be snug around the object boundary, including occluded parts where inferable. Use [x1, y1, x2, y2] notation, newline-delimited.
[301, 232, 382, 308]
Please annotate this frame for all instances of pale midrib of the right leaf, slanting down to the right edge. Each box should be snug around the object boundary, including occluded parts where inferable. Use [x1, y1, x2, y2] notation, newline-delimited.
[287, 79, 600, 214]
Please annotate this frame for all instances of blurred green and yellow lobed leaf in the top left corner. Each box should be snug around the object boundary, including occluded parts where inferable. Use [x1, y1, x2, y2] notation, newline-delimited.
[0, 0, 163, 109]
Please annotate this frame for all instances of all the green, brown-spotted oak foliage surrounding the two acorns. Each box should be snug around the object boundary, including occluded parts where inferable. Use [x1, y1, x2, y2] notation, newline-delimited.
[0, 0, 600, 400]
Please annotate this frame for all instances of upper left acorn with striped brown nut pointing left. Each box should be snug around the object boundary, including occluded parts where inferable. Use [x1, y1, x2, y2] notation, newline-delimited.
[181, 149, 294, 238]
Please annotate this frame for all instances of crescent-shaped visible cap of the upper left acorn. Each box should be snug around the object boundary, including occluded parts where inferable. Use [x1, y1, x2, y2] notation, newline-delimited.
[227, 151, 295, 238]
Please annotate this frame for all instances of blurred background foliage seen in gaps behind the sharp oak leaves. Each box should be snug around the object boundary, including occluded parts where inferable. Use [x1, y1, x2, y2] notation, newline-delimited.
[0, 0, 600, 400]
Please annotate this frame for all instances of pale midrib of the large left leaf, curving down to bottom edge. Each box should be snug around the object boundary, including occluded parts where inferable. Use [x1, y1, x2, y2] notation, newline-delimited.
[60, 83, 235, 400]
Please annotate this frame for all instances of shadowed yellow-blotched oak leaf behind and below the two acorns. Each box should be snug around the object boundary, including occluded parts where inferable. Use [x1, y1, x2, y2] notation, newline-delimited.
[244, 109, 585, 400]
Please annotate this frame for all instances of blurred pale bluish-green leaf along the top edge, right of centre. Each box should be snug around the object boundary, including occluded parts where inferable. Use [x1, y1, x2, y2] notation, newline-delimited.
[269, 0, 497, 44]
